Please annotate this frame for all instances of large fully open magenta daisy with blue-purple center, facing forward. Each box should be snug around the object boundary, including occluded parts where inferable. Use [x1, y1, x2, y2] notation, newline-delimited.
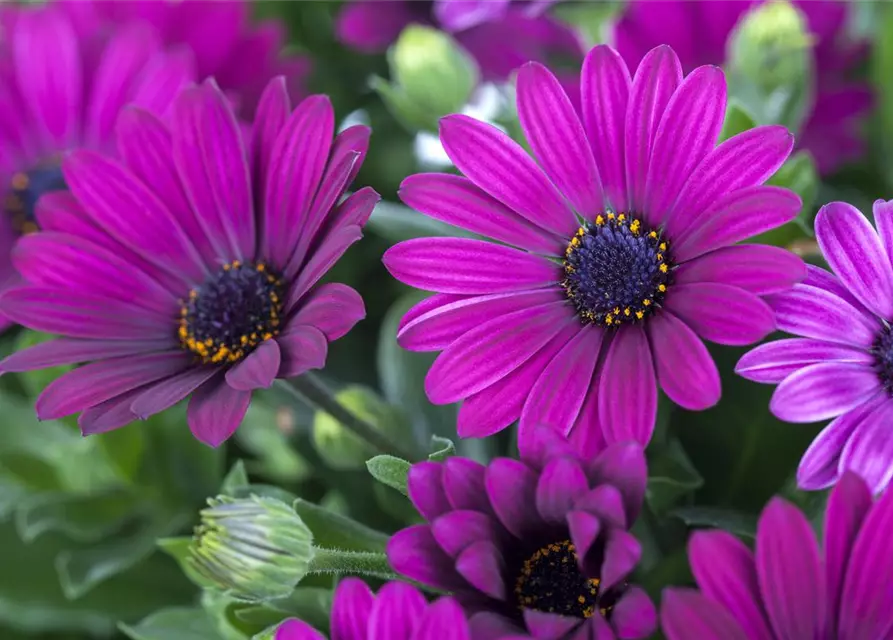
[384, 46, 805, 455]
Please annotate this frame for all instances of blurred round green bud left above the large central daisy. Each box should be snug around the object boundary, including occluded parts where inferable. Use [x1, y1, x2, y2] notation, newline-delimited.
[372, 25, 479, 131]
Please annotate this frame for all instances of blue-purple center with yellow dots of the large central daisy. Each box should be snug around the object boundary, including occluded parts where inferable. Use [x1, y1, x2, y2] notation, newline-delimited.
[562, 212, 673, 327]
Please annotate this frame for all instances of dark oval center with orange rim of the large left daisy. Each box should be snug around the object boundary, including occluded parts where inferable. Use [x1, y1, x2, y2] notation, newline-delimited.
[177, 260, 283, 364]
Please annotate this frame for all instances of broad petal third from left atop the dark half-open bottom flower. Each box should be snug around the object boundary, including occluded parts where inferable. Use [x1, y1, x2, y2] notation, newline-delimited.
[484, 458, 541, 539]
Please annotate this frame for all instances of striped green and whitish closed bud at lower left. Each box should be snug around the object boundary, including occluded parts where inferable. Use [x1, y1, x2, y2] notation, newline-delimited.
[189, 496, 314, 602]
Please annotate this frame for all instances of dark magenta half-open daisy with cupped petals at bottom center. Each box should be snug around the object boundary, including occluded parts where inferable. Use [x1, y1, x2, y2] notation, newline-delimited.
[387, 427, 656, 640]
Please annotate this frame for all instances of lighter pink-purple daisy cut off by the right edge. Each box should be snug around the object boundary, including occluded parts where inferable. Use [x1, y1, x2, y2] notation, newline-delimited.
[735, 200, 893, 492]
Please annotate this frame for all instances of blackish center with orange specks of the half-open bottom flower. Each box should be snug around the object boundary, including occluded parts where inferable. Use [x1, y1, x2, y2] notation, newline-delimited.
[515, 540, 612, 618]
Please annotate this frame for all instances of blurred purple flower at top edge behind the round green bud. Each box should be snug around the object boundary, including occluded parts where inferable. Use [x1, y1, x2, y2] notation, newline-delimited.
[335, 0, 583, 80]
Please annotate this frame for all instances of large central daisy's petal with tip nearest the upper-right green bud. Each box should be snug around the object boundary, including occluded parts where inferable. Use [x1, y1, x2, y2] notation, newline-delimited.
[644, 66, 726, 224]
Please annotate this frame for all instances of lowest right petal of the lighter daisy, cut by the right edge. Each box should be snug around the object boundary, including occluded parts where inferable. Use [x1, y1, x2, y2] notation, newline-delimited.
[838, 399, 893, 494]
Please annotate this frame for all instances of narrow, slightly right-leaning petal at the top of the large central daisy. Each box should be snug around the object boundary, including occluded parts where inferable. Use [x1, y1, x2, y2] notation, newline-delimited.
[624, 45, 682, 211]
